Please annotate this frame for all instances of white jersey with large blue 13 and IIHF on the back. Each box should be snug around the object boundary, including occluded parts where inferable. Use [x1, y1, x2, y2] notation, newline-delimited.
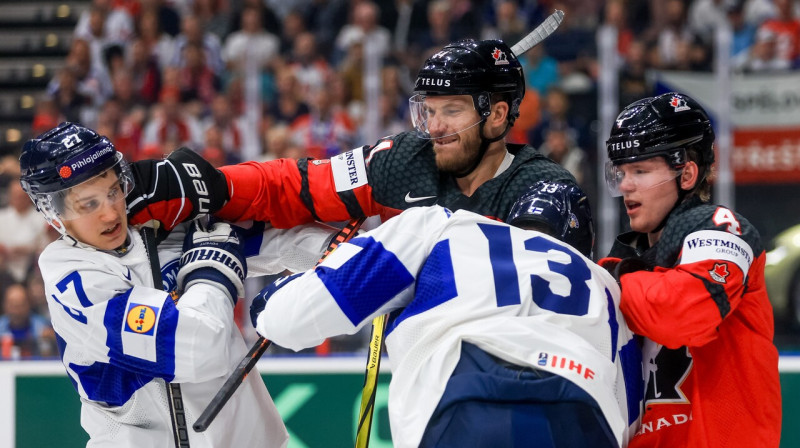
[257, 206, 642, 447]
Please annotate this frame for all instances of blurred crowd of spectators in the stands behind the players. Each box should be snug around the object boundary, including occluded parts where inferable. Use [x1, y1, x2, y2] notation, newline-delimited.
[0, 0, 800, 356]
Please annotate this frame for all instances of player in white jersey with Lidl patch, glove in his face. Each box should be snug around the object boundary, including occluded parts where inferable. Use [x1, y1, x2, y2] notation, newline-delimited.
[20, 123, 331, 448]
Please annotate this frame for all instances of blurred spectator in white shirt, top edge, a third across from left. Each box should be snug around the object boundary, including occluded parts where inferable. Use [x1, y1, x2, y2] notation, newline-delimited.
[222, 7, 279, 71]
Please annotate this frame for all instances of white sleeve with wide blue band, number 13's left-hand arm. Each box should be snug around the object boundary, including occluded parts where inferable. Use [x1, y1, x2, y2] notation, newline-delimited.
[256, 207, 450, 350]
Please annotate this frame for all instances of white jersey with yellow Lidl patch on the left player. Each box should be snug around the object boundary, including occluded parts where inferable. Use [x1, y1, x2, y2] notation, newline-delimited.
[39, 221, 332, 448]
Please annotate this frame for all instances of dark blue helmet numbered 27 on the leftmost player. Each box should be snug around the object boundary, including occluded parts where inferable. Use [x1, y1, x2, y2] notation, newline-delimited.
[19, 122, 133, 234]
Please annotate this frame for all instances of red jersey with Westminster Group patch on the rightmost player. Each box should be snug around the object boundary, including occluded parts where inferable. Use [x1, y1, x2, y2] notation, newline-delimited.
[601, 198, 781, 448]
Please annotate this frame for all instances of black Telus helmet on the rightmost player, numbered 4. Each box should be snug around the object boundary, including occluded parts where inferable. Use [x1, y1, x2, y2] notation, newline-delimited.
[606, 92, 714, 169]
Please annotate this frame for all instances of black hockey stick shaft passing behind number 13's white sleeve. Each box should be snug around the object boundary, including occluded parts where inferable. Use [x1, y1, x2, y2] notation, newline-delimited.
[192, 218, 366, 432]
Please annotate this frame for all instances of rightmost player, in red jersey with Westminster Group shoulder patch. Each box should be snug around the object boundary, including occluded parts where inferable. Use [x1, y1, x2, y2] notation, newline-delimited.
[600, 93, 781, 448]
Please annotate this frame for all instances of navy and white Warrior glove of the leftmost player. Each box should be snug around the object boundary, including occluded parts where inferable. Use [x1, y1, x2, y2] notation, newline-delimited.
[178, 222, 247, 305]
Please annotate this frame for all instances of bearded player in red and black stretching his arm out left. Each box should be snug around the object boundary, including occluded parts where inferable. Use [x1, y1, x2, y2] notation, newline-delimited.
[128, 40, 575, 234]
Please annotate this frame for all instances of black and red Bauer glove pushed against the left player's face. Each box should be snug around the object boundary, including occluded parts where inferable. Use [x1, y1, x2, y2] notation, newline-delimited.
[126, 148, 229, 234]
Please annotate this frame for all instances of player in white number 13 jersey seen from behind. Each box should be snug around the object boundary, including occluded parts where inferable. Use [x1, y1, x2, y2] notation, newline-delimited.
[251, 182, 642, 447]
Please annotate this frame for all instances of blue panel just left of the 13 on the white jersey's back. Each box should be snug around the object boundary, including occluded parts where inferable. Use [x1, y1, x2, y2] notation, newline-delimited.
[386, 240, 458, 335]
